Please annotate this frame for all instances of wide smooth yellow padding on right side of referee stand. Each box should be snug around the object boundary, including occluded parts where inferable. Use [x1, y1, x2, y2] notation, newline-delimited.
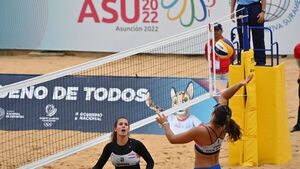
[255, 63, 292, 164]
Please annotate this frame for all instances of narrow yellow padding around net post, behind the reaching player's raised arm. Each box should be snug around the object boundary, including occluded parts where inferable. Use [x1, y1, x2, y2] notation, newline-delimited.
[228, 50, 258, 166]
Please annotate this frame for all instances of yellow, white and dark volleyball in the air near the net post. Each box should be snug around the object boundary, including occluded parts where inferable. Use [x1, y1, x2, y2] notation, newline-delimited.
[215, 38, 234, 59]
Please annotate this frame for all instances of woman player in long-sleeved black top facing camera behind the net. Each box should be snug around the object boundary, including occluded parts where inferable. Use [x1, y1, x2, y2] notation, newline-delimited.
[93, 117, 154, 169]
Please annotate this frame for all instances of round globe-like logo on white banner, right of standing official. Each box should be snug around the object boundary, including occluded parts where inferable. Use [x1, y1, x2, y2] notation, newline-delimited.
[265, 0, 290, 22]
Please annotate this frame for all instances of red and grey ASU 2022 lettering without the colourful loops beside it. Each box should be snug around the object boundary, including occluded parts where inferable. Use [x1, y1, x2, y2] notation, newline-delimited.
[78, 0, 159, 24]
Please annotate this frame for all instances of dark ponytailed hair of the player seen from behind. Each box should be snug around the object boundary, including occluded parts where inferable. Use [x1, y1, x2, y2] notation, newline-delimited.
[213, 104, 242, 141]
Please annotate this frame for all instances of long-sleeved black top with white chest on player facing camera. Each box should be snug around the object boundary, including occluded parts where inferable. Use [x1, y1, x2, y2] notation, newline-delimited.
[93, 138, 154, 169]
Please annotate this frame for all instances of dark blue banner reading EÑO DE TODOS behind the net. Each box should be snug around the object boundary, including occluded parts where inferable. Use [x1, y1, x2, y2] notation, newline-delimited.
[0, 74, 216, 134]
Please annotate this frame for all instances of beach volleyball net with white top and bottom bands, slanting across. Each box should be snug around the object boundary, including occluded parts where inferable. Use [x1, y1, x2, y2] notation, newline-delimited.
[0, 23, 227, 168]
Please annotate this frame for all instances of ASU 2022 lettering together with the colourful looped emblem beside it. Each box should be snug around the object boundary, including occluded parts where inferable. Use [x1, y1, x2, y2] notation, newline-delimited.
[77, 0, 216, 27]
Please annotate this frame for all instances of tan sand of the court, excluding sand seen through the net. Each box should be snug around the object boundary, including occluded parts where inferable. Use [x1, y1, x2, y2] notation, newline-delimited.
[0, 51, 300, 169]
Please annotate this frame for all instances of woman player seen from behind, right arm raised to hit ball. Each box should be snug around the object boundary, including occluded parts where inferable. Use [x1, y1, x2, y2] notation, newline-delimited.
[156, 75, 253, 169]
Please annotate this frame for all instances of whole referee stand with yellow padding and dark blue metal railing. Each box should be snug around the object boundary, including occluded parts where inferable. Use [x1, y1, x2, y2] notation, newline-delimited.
[229, 7, 292, 166]
